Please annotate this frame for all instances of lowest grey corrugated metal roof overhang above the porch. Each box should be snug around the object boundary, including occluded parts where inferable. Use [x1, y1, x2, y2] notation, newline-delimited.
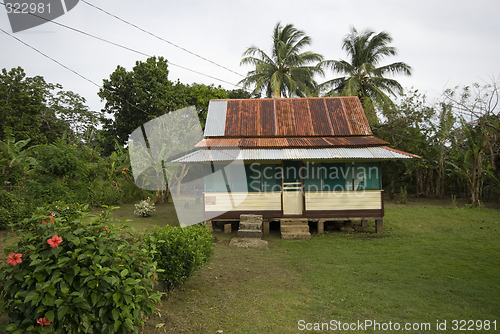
[174, 146, 419, 163]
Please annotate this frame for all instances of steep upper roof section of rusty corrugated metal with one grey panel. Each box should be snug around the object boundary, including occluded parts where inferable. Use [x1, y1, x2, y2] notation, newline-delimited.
[205, 96, 372, 138]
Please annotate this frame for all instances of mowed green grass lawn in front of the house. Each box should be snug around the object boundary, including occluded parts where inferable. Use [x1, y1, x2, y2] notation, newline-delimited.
[0, 202, 500, 334]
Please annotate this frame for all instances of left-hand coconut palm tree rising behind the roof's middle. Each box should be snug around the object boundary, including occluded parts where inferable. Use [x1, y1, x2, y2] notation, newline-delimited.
[240, 23, 323, 97]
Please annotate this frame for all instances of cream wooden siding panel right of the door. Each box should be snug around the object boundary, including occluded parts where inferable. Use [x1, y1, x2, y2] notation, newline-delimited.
[305, 190, 382, 211]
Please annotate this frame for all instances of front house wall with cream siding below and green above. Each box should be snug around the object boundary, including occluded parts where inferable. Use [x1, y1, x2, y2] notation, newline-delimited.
[204, 161, 384, 219]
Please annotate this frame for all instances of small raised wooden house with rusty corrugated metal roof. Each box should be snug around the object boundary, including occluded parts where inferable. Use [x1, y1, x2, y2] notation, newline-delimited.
[179, 97, 418, 238]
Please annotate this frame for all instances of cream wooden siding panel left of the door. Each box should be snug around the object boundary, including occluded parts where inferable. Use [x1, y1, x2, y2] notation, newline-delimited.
[205, 191, 281, 212]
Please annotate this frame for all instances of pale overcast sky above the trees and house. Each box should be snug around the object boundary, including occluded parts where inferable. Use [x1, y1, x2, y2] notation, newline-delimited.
[0, 0, 500, 110]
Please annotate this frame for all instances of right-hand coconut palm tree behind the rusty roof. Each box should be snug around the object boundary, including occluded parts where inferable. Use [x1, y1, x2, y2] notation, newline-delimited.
[321, 27, 411, 124]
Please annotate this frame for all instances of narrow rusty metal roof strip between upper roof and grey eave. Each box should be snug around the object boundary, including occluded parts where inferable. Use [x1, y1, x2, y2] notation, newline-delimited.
[196, 136, 388, 148]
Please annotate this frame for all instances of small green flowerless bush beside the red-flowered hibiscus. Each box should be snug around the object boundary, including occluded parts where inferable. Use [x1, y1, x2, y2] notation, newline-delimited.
[148, 225, 214, 290]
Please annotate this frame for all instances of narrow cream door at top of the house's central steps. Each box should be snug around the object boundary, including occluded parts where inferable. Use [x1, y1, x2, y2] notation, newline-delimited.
[281, 161, 304, 216]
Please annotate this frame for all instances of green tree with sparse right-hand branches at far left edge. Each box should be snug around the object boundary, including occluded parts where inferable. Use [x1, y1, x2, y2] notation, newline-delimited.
[0, 67, 98, 145]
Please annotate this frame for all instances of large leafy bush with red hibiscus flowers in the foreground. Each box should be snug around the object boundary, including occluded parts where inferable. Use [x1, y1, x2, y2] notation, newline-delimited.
[0, 207, 161, 334]
